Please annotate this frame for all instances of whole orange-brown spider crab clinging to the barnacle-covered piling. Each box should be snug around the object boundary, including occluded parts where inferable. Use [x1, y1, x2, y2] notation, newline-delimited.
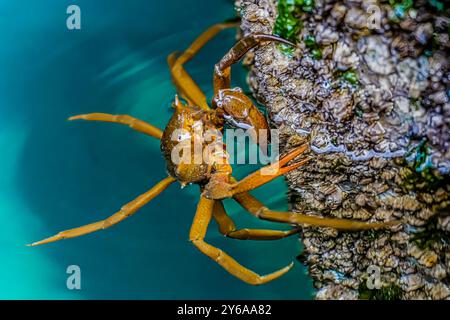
[30, 22, 396, 285]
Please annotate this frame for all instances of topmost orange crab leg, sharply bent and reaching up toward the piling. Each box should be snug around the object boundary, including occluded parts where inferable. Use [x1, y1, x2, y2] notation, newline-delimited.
[167, 23, 239, 110]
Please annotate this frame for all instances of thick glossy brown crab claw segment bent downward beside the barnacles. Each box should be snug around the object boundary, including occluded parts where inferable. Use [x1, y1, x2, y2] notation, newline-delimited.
[213, 88, 270, 143]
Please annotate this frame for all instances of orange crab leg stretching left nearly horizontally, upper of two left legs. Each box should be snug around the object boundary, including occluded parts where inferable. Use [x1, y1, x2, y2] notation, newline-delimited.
[69, 113, 162, 139]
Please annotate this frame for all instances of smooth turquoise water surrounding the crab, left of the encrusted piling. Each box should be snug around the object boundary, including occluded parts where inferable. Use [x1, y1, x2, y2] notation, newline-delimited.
[0, 0, 312, 299]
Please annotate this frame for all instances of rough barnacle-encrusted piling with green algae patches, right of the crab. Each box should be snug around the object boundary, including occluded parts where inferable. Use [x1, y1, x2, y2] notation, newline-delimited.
[236, 0, 450, 299]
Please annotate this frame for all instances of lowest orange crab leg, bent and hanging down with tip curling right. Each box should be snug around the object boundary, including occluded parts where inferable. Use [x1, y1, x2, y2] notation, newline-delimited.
[189, 196, 293, 285]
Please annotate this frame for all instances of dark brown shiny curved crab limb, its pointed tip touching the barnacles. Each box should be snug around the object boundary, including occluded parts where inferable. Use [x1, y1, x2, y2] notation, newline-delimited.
[214, 33, 295, 95]
